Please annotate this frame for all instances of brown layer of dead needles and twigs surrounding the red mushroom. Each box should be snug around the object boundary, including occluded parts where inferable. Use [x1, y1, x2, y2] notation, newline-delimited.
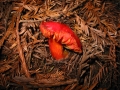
[0, 0, 120, 90]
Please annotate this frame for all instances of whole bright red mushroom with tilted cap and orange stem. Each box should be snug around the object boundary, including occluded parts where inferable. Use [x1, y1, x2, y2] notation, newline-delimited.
[40, 21, 82, 59]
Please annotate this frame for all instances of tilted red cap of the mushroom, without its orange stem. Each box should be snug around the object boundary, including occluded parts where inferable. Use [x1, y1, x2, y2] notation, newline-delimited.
[40, 21, 82, 53]
